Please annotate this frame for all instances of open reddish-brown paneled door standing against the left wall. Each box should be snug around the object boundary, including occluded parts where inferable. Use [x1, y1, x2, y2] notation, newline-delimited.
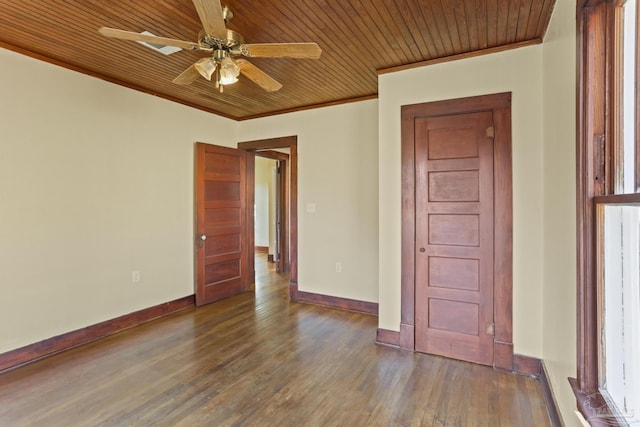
[195, 143, 250, 305]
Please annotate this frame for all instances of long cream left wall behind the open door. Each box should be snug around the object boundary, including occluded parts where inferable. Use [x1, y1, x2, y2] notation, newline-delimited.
[0, 49, 238, 353]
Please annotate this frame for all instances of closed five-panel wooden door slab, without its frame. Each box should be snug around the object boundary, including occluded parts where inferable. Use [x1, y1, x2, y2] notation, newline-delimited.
[415, 111, 494, 365]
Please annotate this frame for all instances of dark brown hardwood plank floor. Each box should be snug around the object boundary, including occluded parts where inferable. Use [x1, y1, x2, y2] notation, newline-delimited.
[0, 255, 550, 427]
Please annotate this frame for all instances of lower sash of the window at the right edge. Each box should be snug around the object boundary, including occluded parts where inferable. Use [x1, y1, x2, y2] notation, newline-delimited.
[596, 196, 640, 426]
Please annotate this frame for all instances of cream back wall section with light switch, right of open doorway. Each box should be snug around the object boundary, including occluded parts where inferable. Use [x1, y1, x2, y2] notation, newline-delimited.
[240, 100, 378, 302]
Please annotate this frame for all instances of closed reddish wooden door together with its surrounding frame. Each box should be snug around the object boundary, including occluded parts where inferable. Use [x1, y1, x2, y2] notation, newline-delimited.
[400, 93, 513, 370]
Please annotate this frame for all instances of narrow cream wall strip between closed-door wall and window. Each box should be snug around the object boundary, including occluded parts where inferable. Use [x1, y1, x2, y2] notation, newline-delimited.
[542, 0, 580, 426]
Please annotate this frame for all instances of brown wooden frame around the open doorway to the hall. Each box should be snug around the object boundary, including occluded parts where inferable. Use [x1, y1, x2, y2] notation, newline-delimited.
[238, 135, 298, 301]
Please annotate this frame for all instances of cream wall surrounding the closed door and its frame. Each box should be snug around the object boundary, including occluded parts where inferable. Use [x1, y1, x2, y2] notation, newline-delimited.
[378, 46, 543, 357]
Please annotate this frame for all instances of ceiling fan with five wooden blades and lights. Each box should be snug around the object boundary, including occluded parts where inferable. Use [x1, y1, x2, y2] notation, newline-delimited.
[98, 0, 322, 92]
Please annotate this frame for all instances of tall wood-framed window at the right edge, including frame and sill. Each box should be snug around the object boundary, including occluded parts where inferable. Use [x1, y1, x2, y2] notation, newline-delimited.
[571, 0, 640, 426]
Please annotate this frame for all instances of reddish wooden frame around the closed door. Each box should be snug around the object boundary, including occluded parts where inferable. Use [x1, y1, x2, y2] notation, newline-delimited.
[400, 92, 513, 371]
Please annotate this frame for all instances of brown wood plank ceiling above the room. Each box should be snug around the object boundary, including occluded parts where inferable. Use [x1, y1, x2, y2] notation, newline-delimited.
[0, 0, 555, 120]
